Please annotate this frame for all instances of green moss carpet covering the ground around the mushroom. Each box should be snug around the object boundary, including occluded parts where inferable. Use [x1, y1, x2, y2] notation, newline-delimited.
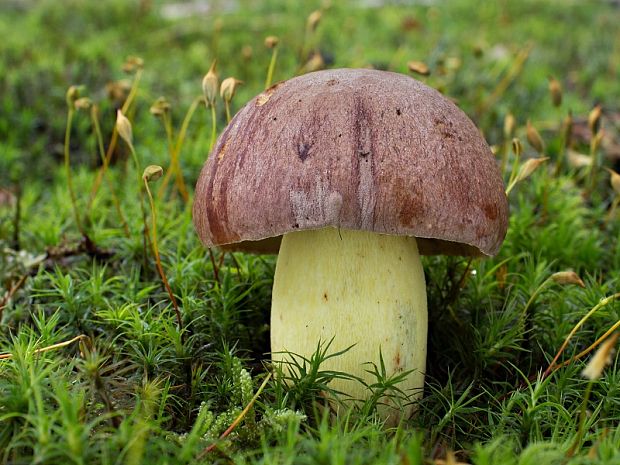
[0, 0, 620, 465]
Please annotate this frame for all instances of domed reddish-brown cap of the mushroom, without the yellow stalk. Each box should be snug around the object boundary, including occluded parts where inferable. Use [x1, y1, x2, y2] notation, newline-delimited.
[194, 69, 508, 255]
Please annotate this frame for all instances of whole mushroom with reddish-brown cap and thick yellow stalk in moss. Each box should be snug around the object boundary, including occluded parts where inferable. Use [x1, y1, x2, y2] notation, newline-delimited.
[194, 69, 508, 417]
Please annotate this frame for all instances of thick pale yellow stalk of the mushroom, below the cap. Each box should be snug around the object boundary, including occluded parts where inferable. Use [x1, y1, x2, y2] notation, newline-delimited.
[271, 228, 428, 418]
